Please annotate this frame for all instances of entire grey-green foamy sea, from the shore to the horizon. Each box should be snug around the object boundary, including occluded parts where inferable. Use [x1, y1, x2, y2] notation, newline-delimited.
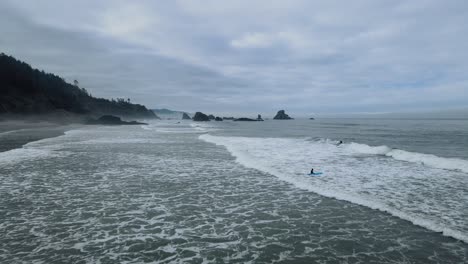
[0, 119, 468, 263]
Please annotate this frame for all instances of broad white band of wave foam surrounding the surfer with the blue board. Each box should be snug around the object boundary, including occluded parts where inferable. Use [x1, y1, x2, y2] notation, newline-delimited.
[199, 134, 468, 242]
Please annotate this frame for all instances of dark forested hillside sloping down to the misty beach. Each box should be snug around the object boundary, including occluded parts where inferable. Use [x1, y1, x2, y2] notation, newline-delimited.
[0, 53, 156, 118]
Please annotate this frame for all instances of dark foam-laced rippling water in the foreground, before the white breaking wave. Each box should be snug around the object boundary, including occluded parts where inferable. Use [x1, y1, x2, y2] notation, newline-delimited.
[0, 125, 468, 263]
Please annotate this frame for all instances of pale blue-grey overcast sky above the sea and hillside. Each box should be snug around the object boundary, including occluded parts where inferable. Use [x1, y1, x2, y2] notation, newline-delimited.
[0, 0, 468, 115]
